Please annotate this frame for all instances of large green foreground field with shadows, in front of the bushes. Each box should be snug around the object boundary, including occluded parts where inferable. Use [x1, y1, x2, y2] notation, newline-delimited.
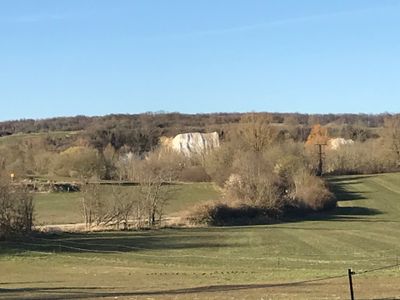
[0, 174, 400, 299]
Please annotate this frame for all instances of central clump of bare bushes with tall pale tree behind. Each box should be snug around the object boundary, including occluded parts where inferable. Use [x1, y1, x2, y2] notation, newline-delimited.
[189, 114, 336, 225]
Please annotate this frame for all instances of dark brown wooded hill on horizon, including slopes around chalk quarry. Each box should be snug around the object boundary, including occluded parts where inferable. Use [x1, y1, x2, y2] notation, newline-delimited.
[0, 113, 390, 153]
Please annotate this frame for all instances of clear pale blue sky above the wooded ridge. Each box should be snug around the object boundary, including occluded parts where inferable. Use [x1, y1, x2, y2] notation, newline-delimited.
[0, 0, 400, 120]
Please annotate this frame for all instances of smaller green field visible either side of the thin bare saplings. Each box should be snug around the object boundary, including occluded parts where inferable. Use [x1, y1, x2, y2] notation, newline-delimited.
[34, 183, 221, 225]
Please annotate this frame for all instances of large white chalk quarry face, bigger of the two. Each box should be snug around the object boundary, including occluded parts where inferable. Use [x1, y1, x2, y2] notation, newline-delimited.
[161, 132, 219, 157]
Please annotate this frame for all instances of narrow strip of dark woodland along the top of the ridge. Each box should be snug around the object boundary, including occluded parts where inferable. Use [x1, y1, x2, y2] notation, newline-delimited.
[0, 112, 389, 136]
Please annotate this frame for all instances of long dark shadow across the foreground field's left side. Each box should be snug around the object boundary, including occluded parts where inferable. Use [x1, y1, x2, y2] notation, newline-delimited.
[0, 230, 239, 255]
